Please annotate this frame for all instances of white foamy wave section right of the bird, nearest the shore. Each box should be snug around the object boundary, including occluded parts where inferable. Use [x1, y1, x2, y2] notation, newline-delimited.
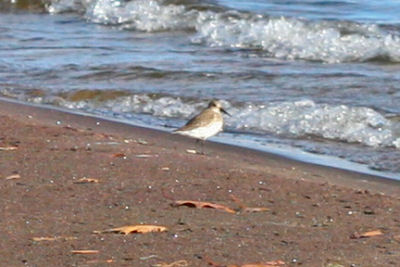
[231, 100, 400, 148]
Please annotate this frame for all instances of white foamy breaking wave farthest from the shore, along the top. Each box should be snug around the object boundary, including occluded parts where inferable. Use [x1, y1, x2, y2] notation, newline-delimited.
[48, 0, 400, 63]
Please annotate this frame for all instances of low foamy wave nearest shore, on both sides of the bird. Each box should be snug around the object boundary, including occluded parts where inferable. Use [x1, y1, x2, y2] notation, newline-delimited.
[18, 90, 400, 148]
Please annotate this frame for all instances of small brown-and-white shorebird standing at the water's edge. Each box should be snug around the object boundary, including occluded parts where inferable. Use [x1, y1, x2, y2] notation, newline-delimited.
[173, 100, 230, 154]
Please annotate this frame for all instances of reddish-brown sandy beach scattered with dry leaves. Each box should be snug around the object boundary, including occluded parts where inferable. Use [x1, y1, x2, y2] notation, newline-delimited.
[0, 100, 400, 267]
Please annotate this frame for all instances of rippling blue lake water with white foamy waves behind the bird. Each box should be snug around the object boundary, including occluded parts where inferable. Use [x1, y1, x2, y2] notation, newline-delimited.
[0, 0, 400, 178]
